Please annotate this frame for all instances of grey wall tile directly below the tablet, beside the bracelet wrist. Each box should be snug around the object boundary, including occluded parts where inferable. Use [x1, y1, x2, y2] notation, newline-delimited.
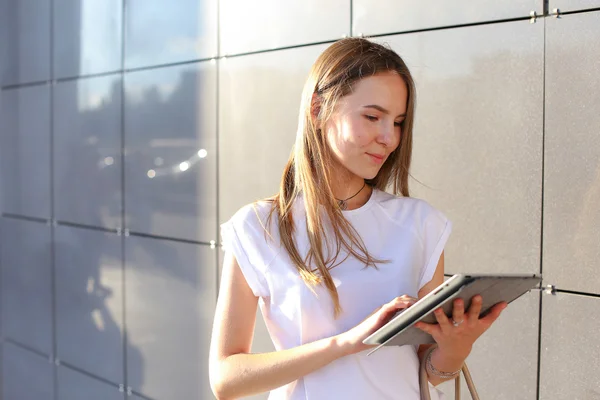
[439, 291, 540, 400]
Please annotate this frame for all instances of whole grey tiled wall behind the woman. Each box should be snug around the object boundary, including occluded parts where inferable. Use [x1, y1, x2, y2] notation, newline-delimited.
[0, 0, 600, 400]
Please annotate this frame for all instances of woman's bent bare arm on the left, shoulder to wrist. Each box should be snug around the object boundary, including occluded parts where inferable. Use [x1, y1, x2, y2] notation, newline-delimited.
[209, 253, 348, 400]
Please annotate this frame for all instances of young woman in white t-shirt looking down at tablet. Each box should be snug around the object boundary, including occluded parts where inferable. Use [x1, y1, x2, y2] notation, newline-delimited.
[210, 38, 506, 400]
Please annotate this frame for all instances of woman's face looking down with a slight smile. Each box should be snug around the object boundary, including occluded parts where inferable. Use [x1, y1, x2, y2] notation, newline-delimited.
[324, 71, 408, 179]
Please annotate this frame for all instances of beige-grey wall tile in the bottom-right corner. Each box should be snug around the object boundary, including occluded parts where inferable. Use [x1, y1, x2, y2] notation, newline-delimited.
[540, 293, 600, 400]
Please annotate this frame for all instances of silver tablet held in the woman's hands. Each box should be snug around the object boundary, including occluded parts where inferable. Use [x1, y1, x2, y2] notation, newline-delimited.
[363, 274, 542, 354]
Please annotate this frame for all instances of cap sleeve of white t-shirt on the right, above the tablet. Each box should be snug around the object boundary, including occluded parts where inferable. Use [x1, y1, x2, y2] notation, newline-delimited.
[419, 203, 452, 289]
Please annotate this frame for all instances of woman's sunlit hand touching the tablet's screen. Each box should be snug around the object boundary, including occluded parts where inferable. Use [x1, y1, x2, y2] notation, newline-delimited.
[337, 295, 417, 355]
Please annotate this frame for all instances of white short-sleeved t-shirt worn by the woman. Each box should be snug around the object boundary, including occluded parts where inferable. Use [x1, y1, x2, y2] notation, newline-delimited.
[221, 189, 452, 400]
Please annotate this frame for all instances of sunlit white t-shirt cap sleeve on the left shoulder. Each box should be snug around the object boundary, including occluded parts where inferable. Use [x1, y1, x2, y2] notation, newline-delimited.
[221, 209, 269, 297]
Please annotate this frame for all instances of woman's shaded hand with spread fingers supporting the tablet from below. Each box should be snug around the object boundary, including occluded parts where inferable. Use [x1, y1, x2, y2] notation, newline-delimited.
[415, 295, 508, 358]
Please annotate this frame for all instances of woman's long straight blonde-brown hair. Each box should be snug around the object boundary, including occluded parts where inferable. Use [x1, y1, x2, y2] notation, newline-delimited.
[267, 38, 415, 318]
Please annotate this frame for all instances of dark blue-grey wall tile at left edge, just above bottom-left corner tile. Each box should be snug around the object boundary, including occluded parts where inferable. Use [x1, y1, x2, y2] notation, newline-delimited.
[0, 218, 53, 355]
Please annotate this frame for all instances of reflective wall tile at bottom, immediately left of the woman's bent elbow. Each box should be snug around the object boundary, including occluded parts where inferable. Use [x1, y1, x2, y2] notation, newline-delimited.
[125, 236, 217, 399]
